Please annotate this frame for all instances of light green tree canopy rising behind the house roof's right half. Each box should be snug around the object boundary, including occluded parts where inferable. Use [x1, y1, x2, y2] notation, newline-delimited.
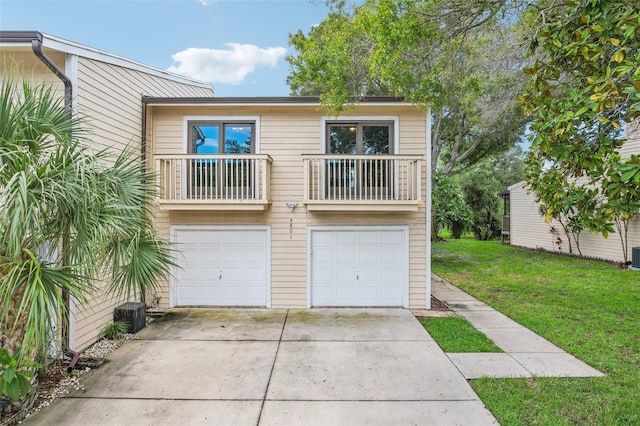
[287, 0, 524, 174]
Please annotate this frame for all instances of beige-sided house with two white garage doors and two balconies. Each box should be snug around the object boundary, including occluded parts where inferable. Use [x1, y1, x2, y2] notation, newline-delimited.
[143, 96, 430, 309]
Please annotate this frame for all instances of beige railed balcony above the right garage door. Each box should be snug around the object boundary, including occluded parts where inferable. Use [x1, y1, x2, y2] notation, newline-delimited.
[303, 154, 423, 211]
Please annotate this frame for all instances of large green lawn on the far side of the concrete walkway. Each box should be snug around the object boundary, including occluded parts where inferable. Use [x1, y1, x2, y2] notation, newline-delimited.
[432, 240, 640, 425]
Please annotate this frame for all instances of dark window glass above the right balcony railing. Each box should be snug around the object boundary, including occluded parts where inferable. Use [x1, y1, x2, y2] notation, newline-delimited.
[326, 121, 393, 154]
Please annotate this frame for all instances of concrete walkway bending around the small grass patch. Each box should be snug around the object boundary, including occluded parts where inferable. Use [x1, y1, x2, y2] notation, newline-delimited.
[418, 274, 604, 379]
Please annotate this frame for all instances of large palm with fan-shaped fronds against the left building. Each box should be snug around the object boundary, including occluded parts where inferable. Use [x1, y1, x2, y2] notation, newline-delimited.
[0, 77, 172, 357]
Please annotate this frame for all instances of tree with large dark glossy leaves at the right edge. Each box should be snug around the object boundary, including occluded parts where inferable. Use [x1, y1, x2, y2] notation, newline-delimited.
[521, 0, 640, 261]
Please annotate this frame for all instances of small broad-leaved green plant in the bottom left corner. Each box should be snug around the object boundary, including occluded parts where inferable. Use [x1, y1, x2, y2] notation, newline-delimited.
[0, 348, 40, 401]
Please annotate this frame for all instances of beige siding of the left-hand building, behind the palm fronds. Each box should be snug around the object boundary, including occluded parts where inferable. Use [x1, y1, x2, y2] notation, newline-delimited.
[0, 46, 213, 350]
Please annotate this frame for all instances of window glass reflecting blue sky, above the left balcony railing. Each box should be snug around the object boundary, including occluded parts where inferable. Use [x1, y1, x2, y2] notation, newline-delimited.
[188, 121, 255, 154]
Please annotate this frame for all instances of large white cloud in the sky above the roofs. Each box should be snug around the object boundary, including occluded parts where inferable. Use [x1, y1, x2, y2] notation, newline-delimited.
[168, 43, 287, 85]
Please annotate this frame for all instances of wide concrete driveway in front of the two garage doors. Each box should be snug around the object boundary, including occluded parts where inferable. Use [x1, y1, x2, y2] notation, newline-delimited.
[24, 309, 497, 425]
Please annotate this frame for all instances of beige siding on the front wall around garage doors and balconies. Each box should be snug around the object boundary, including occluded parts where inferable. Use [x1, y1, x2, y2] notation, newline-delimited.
[149, 106, 426, 308]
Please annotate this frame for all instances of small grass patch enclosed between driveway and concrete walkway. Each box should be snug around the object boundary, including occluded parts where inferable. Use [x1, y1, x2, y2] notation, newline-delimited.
[418, 317, 502, 352]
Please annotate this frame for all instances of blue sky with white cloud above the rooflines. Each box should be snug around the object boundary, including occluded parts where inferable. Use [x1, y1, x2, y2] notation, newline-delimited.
[0, 0, 327, 96]
